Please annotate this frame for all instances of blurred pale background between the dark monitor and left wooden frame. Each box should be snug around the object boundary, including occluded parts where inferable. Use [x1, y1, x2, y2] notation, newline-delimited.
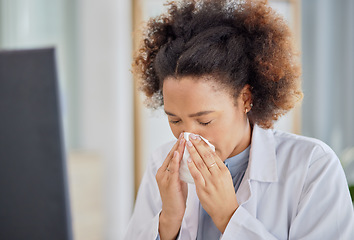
[0, 0, 134, 240]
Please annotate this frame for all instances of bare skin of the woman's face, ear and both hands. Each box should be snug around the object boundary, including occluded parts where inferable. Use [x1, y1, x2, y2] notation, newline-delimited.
[156, 76, 252, 240]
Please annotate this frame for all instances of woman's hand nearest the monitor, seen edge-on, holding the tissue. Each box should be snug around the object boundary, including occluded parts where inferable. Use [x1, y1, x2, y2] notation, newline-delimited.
[156, 134, 188, 239]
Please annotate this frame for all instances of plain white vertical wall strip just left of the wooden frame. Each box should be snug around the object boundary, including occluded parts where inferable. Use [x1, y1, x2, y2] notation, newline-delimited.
[77, 0, 134, 240]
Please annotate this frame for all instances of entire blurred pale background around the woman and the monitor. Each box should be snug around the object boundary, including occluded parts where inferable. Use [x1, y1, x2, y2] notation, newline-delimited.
[0, 0, 354, 240]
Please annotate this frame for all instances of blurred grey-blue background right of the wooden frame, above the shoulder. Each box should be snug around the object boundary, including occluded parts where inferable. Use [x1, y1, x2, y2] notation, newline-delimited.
[302, 0, 354, 185]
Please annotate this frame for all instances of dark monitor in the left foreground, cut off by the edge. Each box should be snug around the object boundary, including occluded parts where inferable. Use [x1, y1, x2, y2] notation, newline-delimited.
[0, 49, 72, 240]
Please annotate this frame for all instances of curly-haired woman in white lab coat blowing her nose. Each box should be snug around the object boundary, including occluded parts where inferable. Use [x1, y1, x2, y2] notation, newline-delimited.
[126, 0, 354, 239]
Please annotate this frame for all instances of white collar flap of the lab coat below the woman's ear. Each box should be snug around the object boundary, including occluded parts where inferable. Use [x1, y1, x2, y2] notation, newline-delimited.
[245, 125, 278, 182]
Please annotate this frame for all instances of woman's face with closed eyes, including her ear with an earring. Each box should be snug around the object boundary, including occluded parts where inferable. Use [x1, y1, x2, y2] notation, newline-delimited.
[163, 76, 251, 161]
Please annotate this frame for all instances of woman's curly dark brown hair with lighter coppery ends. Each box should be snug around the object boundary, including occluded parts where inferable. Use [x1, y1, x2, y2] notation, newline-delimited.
[133, 0, 302, 128]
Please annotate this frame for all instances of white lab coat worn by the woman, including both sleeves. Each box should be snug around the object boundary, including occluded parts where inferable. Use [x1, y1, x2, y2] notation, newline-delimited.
[125, 125, 354, 240]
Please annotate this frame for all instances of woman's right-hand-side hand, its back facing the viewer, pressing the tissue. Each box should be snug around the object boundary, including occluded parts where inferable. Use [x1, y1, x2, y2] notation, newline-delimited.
[187, 135, 239, 233]
